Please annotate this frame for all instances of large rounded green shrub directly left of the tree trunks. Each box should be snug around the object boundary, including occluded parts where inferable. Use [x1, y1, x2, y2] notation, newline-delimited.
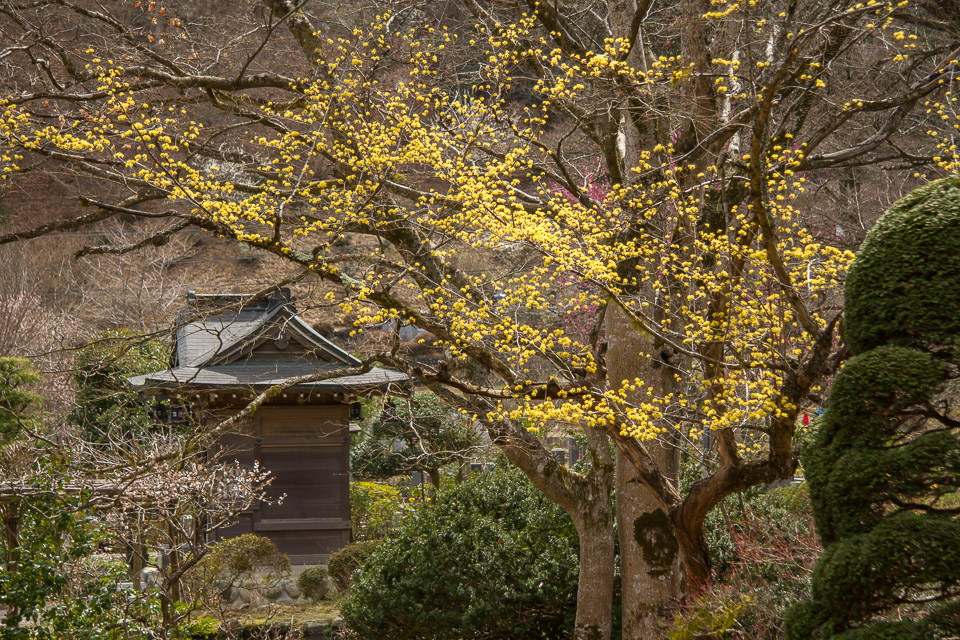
[341, 470, 578, 640]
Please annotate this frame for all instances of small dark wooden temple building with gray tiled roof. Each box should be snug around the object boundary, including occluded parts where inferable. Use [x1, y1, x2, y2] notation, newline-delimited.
[130, 289, 407, 564]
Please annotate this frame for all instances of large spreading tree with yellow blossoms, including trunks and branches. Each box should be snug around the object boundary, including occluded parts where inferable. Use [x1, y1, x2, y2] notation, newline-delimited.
[0, 0, 960, 638]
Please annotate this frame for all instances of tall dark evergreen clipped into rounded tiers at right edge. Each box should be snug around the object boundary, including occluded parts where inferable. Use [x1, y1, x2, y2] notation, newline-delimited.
[786, 177, 960, 640]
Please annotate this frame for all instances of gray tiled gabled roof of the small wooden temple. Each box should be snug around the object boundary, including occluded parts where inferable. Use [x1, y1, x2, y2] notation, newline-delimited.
[129, 296, 407, 390]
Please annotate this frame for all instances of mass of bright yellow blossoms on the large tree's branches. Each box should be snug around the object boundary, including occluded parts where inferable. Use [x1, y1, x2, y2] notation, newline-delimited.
[0, 0, 960, 455]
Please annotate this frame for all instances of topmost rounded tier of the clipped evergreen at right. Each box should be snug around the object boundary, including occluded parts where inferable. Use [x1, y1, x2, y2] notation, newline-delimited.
[844, 176, 960, 353]
